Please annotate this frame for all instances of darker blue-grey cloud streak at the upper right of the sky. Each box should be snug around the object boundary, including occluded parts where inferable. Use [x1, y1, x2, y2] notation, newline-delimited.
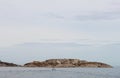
[73, 11, 120, 21]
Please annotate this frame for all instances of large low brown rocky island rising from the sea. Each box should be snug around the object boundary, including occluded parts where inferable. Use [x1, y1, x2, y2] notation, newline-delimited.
[24, 59, 112, 68]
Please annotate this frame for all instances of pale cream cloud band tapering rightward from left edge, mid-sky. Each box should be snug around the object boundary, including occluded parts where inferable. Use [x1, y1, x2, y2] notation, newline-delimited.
[0, 26, 90, 46]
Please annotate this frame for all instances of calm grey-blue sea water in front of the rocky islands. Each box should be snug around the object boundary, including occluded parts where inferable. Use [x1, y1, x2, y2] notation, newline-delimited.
[0, 67, 120, 78]
